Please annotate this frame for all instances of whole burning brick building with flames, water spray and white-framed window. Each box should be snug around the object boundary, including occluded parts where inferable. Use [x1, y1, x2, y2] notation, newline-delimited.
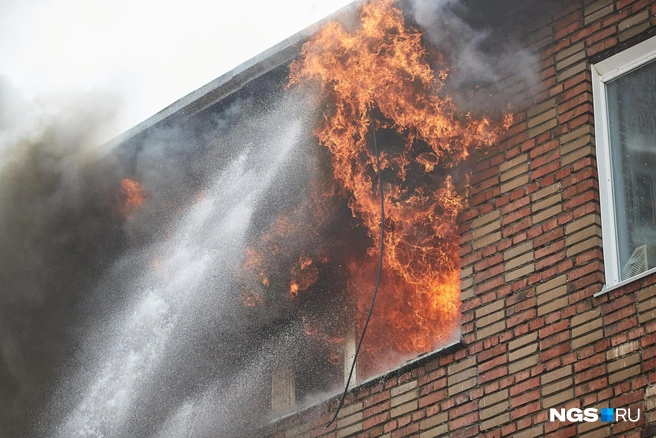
[3, 0, 656, 438]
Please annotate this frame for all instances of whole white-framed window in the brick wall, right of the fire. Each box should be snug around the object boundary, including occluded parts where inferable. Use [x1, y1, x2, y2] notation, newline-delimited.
[592, 38, 656, 288]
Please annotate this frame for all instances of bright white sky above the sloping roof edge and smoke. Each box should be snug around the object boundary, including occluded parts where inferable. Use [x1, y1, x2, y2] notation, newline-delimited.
[0, 0, 351, 134]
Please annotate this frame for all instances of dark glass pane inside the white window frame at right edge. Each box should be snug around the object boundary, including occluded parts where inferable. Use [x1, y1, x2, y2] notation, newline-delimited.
[606, 62, 656, 280]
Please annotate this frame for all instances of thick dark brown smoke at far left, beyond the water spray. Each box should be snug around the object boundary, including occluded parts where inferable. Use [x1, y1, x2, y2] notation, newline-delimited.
[0, 78, 129, 437]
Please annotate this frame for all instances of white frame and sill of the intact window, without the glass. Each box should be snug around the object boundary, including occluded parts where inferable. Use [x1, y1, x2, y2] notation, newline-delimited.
[592, 37, 656, 296]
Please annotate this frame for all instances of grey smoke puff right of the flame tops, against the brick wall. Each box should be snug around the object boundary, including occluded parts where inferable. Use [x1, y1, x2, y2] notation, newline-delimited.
[410, 0, 539, 112]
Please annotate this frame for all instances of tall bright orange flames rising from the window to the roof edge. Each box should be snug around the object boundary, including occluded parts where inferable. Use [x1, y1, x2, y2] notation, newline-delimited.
[290, 0, 511, 372]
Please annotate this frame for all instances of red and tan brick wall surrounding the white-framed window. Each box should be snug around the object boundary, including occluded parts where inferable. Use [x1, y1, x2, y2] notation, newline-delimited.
[263, 0, 656, 438]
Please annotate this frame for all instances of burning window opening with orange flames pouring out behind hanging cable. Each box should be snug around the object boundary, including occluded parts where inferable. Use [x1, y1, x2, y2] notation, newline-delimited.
[240, 0, 510, 410]
